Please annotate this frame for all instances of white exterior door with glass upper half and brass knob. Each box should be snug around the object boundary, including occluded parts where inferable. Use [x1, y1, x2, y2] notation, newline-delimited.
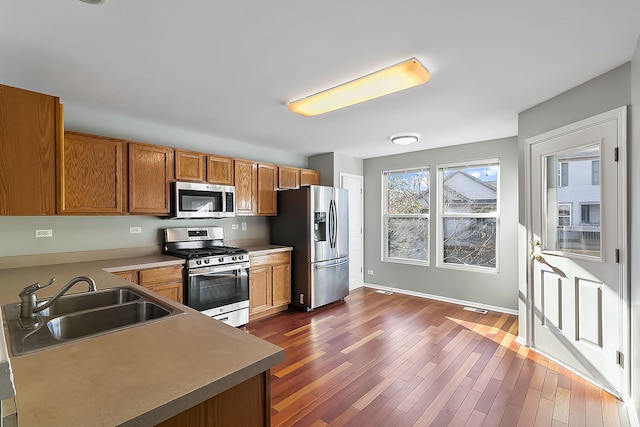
[526, 107, 628, 396]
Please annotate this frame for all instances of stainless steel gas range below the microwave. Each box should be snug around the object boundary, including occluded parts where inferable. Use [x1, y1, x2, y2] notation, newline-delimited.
[163, 227, 249, 326]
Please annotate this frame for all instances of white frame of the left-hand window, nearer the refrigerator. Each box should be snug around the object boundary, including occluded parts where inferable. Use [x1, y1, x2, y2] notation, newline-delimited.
[380, 165, 432, 266]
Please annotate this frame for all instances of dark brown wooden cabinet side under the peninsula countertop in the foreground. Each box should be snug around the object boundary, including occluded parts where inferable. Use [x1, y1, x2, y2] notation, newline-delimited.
[158, 371, 271, 427]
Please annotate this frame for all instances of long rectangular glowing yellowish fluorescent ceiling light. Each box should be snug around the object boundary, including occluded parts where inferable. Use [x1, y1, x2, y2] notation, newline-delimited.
[288, 58, 431, 117]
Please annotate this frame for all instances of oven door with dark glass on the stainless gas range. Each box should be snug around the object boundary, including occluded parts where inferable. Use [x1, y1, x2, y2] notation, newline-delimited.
[187, 268, 249, 311]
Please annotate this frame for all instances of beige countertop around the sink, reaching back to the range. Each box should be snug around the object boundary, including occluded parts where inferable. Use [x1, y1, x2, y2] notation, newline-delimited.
[0, 255, 284, 427]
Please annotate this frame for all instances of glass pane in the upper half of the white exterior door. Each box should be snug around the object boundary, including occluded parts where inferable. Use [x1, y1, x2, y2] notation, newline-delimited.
[545, 145, 600, 256]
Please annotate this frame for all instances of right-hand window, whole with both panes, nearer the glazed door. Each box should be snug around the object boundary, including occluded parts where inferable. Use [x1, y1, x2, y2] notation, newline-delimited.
[438, 159, 500, 271]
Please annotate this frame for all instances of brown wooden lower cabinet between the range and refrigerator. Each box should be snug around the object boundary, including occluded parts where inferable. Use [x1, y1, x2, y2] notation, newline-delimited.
[249, 252, 291, 320]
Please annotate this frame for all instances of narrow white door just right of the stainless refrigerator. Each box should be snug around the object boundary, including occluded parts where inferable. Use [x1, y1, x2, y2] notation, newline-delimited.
[340, 173, 363, 290]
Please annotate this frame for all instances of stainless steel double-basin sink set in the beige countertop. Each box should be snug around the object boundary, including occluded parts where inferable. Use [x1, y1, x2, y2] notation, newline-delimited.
[4, 286, 183, 356]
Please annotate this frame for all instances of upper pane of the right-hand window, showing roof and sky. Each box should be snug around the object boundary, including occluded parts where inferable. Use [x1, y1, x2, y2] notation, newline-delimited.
[442, 164, 500, 213]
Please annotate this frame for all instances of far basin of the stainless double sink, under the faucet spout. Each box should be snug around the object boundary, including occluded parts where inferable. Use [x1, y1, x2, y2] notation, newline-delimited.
[37, 288, 140, 317]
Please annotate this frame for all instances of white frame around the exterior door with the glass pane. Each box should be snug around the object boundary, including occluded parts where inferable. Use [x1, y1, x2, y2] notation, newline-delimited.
[521, 106, 631, 401]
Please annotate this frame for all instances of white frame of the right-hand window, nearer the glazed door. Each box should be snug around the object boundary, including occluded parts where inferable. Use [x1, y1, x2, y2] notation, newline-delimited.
[436, 157, 501, 274]
